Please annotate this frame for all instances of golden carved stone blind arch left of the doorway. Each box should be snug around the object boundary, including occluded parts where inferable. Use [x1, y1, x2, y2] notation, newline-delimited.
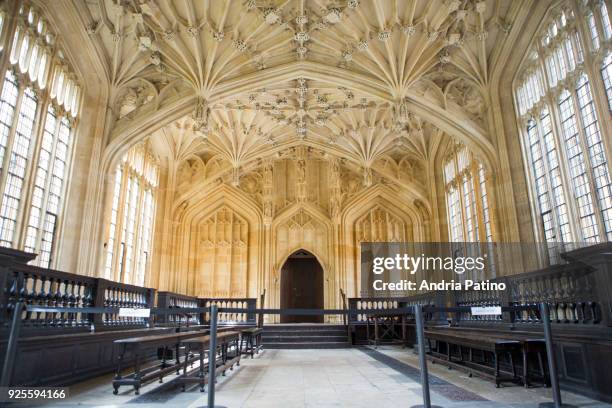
[160, 184, 263, 297]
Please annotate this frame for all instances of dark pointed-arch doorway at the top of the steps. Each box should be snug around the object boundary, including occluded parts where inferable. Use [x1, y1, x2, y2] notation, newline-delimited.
[280, 249, 324, 323]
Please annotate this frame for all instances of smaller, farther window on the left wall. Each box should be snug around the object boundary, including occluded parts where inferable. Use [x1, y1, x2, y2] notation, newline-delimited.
[104, 142, 158, 286]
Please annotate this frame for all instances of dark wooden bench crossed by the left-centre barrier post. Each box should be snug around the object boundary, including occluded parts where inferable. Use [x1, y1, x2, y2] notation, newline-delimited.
[178, 331, 241, 392]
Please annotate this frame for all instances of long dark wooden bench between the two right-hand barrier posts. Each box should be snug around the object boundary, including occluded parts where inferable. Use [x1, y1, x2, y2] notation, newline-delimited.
[425, 328, 522, 387]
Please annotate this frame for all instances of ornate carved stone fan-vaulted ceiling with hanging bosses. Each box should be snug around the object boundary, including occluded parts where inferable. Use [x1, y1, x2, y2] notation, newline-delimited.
[74, 0, 522, 194]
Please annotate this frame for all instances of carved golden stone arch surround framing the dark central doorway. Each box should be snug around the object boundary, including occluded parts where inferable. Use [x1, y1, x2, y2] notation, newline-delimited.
[265, 202, 337, 320]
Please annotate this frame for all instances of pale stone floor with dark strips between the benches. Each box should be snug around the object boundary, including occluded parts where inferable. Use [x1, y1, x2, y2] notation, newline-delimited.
[39, 346, 612, 408]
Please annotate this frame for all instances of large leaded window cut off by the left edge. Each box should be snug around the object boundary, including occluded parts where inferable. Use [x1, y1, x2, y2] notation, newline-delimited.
[0, 4, 81, 267]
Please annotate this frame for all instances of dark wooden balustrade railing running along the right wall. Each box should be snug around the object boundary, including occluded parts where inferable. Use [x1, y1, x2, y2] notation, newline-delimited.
[348, 243, 612, 327]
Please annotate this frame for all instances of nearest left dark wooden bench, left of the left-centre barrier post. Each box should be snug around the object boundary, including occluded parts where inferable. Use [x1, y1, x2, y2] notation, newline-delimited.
[113, 331, 204, 395]
